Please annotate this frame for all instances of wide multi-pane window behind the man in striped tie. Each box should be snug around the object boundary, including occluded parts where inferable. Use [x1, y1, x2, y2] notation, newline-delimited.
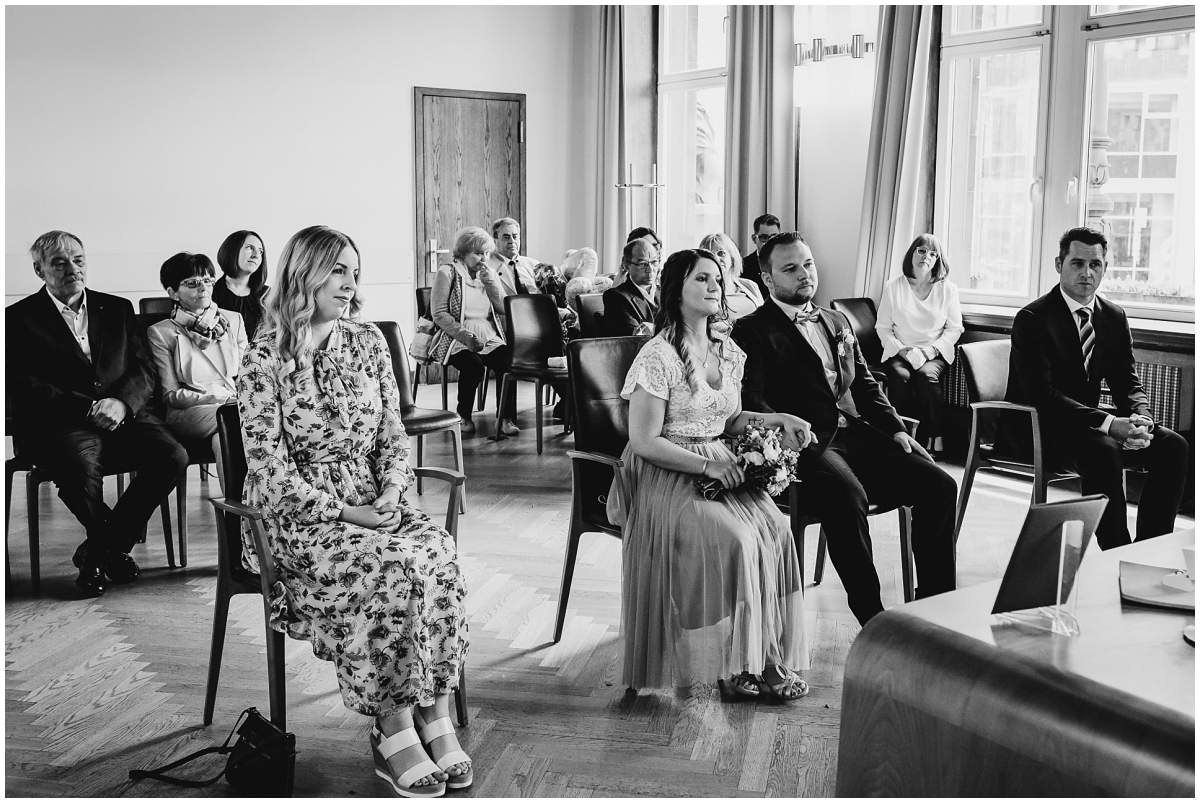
[935, 5, 1195, 320]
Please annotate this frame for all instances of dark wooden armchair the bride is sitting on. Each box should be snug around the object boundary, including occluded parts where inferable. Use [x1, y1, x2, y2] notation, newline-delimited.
[554, 337, 647, 642]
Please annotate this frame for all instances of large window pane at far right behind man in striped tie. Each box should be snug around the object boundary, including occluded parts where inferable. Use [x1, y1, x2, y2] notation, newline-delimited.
[1084, 31, 1195, 306]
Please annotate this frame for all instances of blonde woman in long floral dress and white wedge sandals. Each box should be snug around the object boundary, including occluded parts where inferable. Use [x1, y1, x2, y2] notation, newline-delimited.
[238, 226, 473, 797]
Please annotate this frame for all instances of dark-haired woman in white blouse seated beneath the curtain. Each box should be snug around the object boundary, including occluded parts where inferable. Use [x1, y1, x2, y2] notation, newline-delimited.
[875, 234, 962, 450]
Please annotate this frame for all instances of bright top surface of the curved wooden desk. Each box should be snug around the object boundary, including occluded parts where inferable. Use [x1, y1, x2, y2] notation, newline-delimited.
[889, 532, 1196, 720]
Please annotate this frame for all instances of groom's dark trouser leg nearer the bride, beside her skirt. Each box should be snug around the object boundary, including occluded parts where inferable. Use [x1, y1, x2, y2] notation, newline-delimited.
[799, 430, 883, 624]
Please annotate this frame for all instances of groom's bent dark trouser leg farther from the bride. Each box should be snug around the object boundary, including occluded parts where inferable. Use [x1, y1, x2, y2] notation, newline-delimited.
[847, 425, 959, 599]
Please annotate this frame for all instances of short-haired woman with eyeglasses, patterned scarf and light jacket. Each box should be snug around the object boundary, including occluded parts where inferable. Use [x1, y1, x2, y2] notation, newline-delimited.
[146, 252, 247, 465]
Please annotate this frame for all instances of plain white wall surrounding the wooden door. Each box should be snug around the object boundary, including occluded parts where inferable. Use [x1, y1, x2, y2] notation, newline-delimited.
[5, 6, 594, 331]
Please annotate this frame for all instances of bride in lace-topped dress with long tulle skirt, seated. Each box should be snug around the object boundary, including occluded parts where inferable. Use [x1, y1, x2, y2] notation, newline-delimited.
[608, 250, 811, 700]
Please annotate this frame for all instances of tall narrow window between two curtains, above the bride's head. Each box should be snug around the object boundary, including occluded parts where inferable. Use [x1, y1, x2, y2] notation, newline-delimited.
[657, 6, 728, 251]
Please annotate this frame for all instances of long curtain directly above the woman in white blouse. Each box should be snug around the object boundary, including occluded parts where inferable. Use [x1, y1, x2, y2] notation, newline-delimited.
[854, 6, 942, 299]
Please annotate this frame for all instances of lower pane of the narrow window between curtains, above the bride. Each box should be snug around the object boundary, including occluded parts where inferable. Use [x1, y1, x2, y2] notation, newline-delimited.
[659, 84, 725, 248]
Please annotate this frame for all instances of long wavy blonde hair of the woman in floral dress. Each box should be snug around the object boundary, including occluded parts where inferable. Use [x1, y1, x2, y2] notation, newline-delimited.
[260, 226, 362, 368]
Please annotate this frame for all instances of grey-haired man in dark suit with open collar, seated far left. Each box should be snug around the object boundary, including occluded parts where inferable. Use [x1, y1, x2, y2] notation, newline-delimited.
[5, 232, 187, 597]
